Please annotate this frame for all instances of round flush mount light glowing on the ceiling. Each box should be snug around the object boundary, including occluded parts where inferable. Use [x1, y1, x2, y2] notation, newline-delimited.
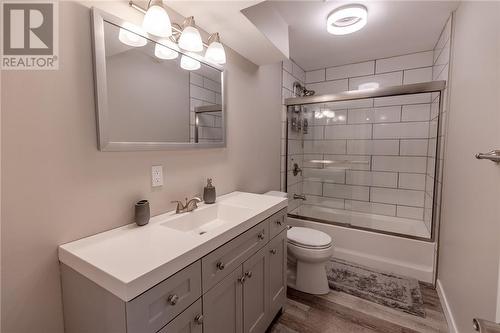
[326, 5, 368, 35]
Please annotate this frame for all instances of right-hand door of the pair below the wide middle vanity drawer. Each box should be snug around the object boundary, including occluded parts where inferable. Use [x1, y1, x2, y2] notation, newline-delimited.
[243, 247, 269, 333]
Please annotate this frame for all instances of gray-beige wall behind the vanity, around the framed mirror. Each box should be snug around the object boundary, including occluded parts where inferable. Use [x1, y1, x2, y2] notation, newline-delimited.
[1, 1, 281, 333]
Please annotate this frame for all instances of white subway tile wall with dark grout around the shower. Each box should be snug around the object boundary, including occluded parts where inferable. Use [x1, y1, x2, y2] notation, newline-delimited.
[282, 42, 447, 230]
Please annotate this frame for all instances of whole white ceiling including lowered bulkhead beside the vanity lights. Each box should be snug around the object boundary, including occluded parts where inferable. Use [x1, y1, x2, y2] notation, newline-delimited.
[147, 0, 459, 70]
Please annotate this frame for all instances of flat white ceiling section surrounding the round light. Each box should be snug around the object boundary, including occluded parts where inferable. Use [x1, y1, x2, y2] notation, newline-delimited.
[273, 1, 459, 70]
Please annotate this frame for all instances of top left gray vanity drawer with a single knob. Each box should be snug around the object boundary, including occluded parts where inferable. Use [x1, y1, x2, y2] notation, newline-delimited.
[126, 261, 201, 333]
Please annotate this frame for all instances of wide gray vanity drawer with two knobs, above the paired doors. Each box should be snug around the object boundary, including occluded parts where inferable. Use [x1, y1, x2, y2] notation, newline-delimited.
[201, 220, 269, 292]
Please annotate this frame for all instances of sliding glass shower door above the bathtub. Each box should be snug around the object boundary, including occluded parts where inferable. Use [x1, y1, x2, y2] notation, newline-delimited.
[287, 92, 439, 239]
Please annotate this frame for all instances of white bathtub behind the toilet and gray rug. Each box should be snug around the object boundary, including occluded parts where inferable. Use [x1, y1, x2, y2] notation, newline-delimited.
[288, 205, 436, 283]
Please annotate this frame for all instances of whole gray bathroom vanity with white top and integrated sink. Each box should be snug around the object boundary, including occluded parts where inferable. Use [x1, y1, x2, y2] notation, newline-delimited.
[59, 192, 287, 333]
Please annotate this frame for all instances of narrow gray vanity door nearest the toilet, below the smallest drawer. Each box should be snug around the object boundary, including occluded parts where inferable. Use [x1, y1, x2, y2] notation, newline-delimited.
[267, 230, 287, 317]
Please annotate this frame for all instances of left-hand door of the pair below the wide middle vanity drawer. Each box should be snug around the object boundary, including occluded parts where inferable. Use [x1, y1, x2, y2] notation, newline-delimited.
[203, 266, 244, 333]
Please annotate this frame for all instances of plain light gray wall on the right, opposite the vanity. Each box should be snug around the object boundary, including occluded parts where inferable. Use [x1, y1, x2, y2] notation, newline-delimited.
[438, 2, 500, 333]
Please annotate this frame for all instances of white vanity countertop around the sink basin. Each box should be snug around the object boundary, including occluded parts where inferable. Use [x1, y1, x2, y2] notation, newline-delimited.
[59, 192, 287, 301]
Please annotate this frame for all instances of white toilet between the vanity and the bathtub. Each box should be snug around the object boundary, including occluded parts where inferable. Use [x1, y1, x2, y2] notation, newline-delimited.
[287, 227, 333, 295]
